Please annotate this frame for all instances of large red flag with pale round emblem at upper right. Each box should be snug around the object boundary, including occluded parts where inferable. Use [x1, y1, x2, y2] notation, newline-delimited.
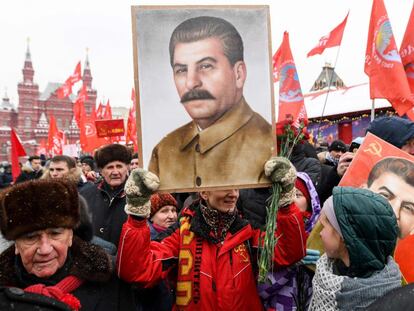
[365, 0, 413, 116]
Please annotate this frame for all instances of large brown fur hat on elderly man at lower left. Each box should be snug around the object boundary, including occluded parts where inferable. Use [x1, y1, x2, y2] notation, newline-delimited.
[0, 179, 80, 240]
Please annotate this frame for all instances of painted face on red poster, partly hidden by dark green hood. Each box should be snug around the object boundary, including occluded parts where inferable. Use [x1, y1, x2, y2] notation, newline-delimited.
[369, 172, 414, 237]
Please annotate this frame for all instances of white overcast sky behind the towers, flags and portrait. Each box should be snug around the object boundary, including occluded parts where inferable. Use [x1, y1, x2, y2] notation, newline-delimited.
[0, 0, 413, 107]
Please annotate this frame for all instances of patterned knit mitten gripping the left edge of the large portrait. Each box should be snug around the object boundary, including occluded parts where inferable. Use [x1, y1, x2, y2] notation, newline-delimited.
[125, 168, 160, 218]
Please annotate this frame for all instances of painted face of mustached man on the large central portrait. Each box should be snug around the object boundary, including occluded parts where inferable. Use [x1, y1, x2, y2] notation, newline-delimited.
[173, 37, 246, 128]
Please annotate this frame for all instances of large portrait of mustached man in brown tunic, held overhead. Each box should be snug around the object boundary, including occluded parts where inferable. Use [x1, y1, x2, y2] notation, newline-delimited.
[131, 5, 275, 192]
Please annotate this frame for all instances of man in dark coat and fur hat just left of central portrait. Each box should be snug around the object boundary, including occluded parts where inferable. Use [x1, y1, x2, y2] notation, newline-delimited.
[80, 144, 131, 246]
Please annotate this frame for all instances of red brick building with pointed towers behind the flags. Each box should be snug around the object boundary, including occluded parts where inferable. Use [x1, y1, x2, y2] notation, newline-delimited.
[0, 46, 97, 161]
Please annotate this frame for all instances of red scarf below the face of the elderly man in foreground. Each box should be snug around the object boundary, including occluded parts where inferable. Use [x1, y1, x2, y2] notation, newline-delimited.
[24, 275, 83, 311]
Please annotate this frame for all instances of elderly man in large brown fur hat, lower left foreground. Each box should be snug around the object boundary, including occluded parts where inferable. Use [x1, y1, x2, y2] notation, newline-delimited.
[0, 180, 135, 311]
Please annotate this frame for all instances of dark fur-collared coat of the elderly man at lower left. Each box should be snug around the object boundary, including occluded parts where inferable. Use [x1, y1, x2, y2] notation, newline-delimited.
[0, 236, 135, 311]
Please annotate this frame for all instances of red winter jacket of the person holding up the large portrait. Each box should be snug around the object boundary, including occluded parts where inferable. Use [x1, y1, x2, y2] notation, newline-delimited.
[117, 204, 306, 311]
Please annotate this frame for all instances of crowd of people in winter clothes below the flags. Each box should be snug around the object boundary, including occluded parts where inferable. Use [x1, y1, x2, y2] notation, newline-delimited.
[0, 117, 414, 310]
